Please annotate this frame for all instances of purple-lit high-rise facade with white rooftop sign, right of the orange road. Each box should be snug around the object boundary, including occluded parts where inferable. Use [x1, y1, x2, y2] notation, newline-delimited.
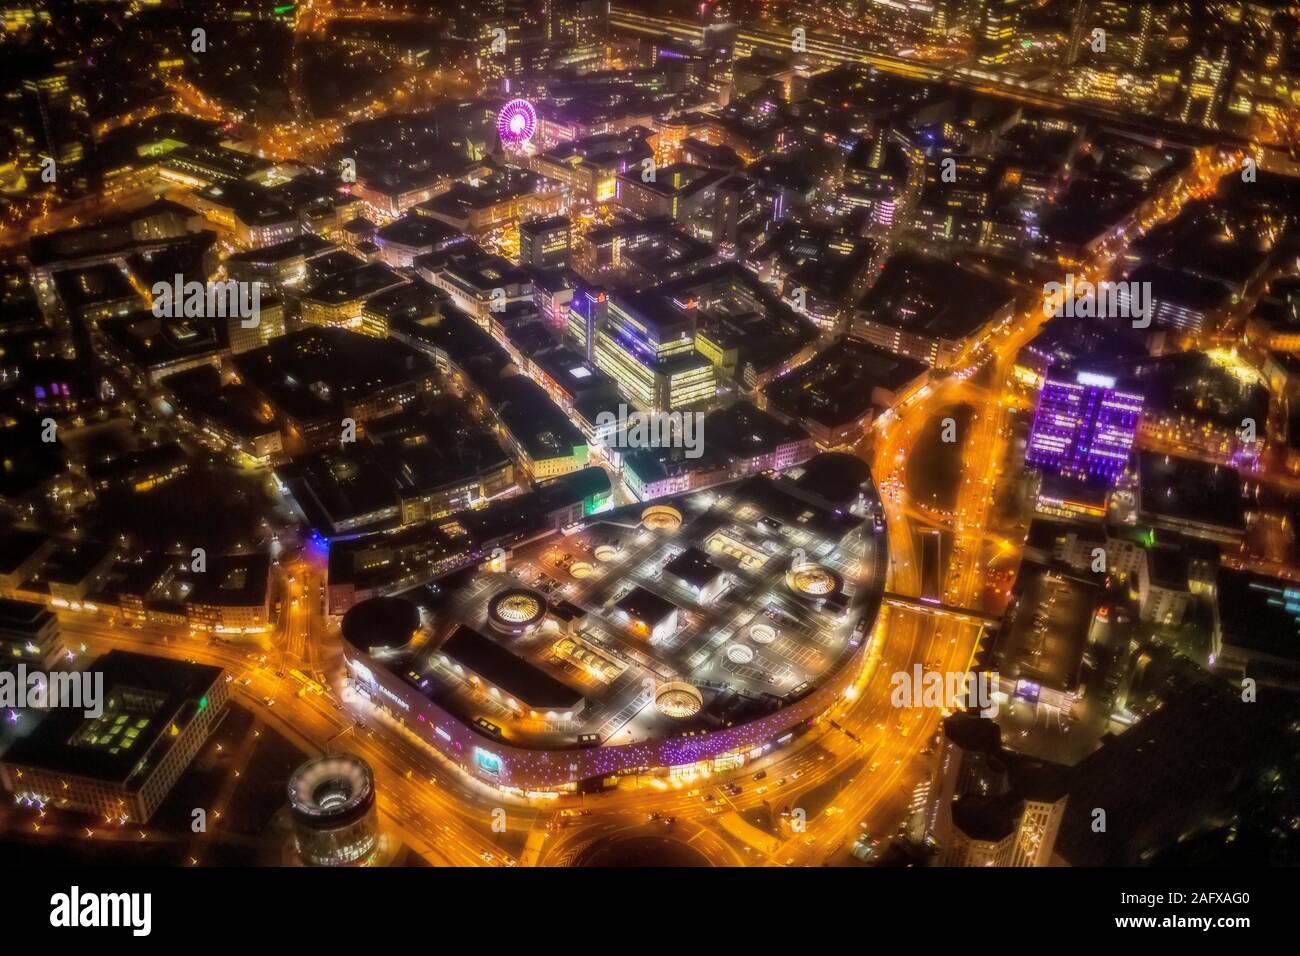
[1024, 372, 1143, 481]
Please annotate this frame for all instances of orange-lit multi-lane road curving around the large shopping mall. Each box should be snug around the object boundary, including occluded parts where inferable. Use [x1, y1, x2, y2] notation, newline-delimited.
[17, 140, 1221, 866]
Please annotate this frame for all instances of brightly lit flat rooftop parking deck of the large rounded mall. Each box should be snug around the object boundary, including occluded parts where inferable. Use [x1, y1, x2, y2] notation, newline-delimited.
[353, 468, 884, 748]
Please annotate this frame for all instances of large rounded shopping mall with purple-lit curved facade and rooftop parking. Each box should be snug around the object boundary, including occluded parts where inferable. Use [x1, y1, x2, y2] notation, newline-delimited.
[343, 454, 887, 792]
